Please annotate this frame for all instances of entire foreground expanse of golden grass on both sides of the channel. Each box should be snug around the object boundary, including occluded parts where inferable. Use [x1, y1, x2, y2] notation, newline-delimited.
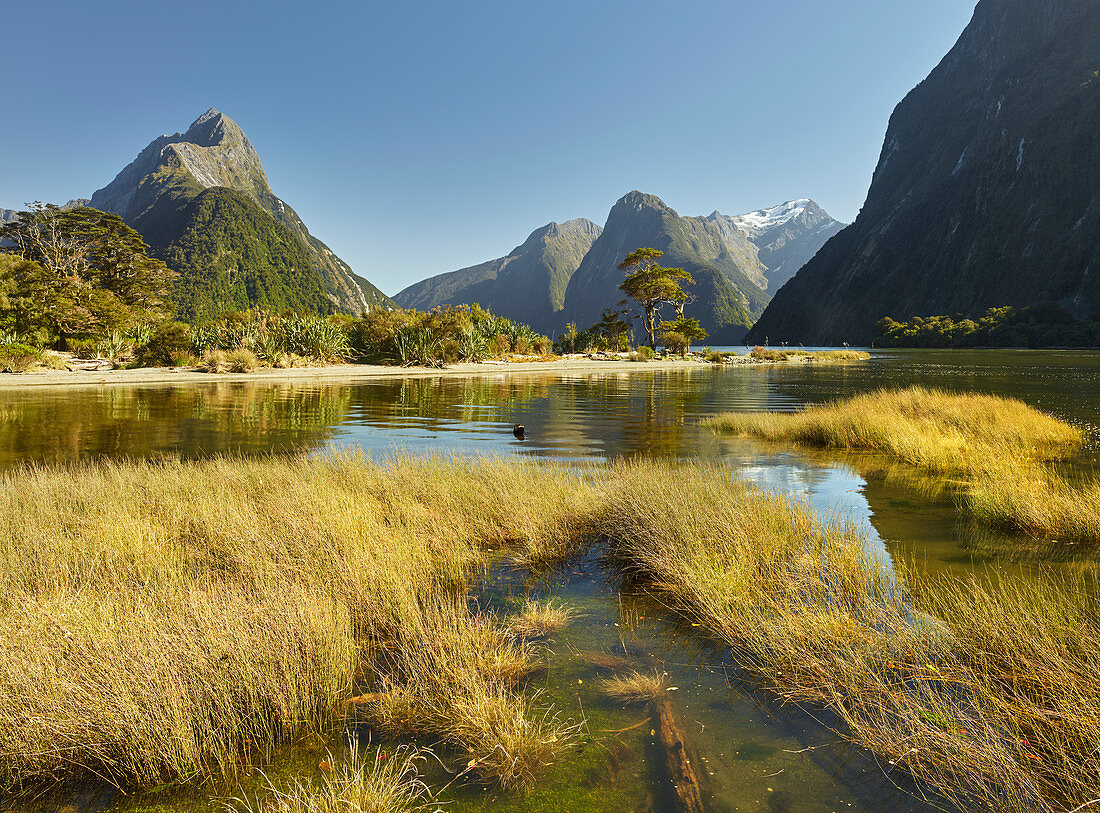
[0, 455, 1100, 811]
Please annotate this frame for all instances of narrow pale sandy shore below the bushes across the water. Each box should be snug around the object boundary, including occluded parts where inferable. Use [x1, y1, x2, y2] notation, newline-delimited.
[0, 359, 713, 389]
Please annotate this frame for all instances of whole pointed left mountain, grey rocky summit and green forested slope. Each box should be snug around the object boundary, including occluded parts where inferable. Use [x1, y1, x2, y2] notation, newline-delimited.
[89, 108, 392, 318]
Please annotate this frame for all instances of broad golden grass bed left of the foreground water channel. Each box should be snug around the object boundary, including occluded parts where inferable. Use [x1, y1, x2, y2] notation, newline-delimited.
[0, 455, 592, 787]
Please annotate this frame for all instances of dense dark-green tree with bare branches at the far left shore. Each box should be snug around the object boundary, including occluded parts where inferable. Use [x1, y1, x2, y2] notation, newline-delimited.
[0, 202, 175, 344]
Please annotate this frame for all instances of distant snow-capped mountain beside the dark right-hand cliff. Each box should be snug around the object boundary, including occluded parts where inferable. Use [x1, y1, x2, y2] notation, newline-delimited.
[708, 198, 845, 293]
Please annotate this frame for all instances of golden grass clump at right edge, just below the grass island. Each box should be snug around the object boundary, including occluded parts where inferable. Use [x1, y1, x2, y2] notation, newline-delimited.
[964, 465, 1100, 548]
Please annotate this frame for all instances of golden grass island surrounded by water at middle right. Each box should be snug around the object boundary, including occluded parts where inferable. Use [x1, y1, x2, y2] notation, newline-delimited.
[701, 386, 1084, 474]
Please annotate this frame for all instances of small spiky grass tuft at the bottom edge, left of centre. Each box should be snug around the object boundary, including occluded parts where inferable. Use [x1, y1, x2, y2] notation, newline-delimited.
[227, 743, 432, 813]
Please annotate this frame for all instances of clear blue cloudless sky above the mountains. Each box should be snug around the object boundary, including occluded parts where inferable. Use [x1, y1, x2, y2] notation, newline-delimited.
[0, 0, 974, 294]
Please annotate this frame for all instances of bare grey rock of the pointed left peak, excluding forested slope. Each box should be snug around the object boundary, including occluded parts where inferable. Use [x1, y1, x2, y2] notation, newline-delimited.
[90, 108, 392, 312]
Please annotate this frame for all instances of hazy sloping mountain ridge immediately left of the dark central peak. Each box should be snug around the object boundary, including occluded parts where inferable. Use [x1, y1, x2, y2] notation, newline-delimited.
[394, 218, 602, 331]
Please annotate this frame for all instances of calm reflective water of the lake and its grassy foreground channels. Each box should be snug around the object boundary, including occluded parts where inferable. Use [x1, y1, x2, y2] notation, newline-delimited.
[8, 351, 1100, 813]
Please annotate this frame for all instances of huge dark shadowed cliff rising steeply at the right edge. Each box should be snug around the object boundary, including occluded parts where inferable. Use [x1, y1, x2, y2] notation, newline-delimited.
[748, 0, 1100, 344]
